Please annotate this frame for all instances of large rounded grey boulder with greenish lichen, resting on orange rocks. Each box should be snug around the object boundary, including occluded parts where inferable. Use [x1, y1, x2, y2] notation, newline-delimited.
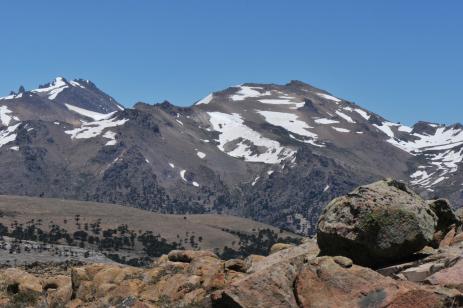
[317, 179, 438, 267]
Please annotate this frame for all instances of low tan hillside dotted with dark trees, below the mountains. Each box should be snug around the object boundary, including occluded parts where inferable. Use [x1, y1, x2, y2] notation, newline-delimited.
[0, 196, 299, 264]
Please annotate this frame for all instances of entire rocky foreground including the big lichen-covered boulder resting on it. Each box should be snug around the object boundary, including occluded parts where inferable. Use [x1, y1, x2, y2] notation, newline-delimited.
[0, 180, 463, 307]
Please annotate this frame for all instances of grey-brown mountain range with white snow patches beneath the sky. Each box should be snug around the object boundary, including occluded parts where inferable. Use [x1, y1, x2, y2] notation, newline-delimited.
[0, 78, 463, 233]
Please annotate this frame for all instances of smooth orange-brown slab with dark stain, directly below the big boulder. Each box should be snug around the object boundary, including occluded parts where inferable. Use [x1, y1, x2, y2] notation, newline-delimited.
[295, 257, 444, 307]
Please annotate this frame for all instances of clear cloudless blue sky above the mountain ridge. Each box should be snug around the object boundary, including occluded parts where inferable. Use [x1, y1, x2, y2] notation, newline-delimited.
[0, 0, 463, 124]
